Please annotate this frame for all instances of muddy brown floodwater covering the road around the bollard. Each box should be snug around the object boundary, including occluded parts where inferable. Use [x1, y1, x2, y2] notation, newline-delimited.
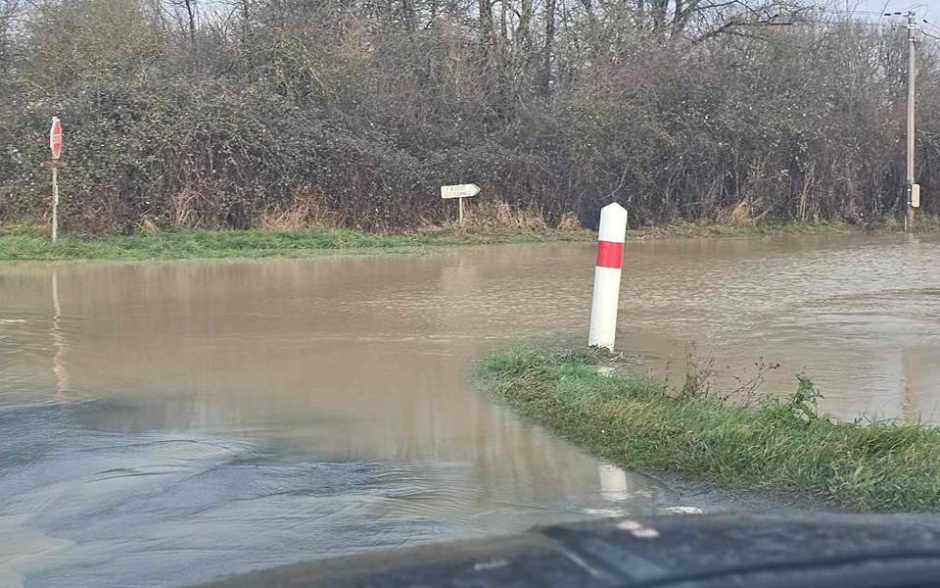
[0, 236, 940, 586]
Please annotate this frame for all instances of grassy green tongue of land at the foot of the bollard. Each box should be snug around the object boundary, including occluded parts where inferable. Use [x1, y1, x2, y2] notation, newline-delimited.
[484, 350, 940, 511]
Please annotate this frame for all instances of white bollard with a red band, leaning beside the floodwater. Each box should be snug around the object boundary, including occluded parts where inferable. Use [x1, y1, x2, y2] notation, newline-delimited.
[588, 202, 627, 351]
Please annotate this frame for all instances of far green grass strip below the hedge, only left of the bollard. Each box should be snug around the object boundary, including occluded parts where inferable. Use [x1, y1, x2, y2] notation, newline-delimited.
[0, 226, 594, 261]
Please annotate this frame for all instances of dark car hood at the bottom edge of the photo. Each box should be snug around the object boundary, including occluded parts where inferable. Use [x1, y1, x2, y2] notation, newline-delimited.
[193, 514, 940, 588]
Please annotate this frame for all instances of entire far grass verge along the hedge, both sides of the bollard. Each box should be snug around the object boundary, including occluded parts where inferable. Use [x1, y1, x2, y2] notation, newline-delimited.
[0, 221, 940, 263]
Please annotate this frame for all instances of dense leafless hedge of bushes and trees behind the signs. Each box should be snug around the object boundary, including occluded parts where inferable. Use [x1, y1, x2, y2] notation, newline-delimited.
[0, 0, 940, 232]
